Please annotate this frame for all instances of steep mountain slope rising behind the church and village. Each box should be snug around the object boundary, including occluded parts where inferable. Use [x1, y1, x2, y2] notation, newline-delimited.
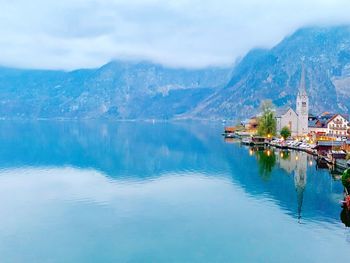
[189, 26, 350, 119]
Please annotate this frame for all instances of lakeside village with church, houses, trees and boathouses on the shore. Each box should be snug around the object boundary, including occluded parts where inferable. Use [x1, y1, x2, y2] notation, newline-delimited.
[223, 67, 350, 171]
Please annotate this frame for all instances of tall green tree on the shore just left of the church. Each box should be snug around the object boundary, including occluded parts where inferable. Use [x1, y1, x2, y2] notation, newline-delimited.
[258, 100, 276, 136]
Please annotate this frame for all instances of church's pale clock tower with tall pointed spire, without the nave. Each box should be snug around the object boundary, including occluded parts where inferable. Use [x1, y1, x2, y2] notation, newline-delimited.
[296, 65, 309, 136]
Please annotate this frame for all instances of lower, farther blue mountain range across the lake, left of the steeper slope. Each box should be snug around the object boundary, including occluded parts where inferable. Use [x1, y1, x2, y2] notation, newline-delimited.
[0, 61, 231, 119]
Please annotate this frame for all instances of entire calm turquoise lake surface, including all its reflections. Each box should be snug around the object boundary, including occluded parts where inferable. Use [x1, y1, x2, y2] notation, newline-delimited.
[0, 121, 350, 262]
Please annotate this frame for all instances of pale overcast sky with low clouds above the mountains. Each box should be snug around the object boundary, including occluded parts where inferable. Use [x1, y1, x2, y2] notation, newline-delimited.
[0, 0, 350, 70]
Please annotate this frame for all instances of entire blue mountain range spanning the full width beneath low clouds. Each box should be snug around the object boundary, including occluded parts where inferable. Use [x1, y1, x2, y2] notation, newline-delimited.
[0, 26, 350, 119]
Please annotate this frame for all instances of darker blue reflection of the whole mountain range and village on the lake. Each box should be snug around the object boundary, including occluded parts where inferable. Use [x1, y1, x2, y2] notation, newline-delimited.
[0, 121, 342, 223]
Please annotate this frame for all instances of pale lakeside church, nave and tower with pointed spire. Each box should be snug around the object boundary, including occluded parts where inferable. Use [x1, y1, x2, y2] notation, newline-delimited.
[276, 67, 309, 136]
